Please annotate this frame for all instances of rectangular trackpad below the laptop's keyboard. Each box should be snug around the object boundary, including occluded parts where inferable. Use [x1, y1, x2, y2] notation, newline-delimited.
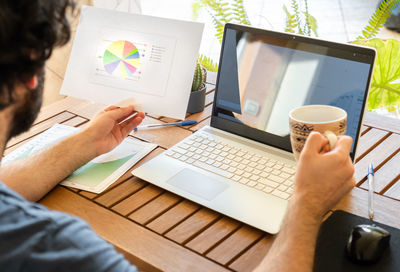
[167, 168, 229, 201]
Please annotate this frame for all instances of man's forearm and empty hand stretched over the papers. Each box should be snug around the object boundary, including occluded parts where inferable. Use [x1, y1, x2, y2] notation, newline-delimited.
[0, 106, 144, 201]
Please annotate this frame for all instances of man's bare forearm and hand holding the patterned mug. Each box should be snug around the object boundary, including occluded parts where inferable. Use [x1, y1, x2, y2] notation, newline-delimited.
[255, 133, 355, 272]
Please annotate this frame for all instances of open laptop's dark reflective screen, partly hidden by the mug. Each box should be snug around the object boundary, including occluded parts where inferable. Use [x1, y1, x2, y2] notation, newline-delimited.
[212, 25, 375, 157]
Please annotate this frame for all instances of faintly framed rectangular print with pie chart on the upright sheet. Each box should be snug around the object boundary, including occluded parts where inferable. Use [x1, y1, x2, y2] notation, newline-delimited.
[94, 28, 176, 98]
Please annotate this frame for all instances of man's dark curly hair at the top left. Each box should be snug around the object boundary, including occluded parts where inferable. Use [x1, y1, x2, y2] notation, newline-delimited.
[0, 0, 75, 110]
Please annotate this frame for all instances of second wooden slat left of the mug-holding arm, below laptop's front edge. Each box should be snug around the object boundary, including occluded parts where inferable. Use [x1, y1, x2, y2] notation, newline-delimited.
[207, 225, 263, 265]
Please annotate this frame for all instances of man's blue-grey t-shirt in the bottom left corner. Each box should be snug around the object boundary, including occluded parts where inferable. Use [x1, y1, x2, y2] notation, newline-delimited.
[0, 182, 137, 272]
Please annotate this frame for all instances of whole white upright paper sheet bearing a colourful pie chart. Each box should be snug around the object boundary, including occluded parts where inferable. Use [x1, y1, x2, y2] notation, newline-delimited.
[61, 6, 204, 119]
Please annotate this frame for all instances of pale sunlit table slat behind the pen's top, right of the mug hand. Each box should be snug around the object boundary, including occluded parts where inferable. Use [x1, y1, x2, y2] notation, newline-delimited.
[354, 134, 400, 182]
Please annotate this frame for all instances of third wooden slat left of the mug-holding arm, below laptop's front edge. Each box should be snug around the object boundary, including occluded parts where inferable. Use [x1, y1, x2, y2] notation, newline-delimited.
[186, 216, 240, 254]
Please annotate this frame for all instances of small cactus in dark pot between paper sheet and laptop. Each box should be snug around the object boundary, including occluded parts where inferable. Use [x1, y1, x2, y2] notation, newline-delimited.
[187, 62, 207, 113]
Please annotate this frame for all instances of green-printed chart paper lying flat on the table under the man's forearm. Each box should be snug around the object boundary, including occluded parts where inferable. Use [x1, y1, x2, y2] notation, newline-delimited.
[2, 124, 157, 193]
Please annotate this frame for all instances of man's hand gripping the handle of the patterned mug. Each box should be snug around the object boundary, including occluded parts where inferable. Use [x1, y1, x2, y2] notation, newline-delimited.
[292, 132, 355, 221]
